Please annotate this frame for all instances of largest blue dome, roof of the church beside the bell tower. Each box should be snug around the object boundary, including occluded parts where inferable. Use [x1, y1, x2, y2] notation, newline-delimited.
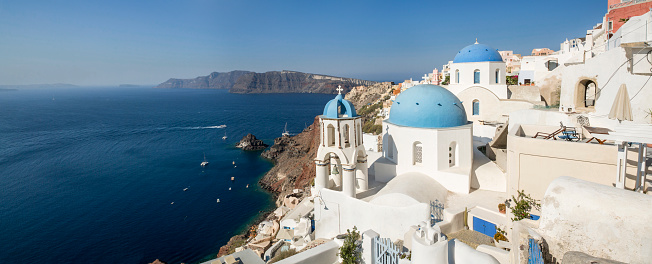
[389, 84, 467, 128]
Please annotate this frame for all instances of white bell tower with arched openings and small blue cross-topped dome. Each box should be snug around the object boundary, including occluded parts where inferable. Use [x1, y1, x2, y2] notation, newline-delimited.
[315, 86, 369, 197]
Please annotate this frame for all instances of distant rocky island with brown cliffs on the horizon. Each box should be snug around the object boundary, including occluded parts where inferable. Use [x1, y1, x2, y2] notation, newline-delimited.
[155, 71, 377, 94]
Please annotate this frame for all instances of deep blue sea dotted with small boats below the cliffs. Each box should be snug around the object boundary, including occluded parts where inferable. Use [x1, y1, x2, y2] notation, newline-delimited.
[0, 87, 333, 263]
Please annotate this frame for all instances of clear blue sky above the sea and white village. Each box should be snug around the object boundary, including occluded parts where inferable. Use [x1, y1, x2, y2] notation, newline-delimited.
[0, 0, 607, 85]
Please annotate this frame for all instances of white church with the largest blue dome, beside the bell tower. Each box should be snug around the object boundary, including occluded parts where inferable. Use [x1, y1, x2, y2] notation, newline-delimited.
[375, 85, 473, 193]
